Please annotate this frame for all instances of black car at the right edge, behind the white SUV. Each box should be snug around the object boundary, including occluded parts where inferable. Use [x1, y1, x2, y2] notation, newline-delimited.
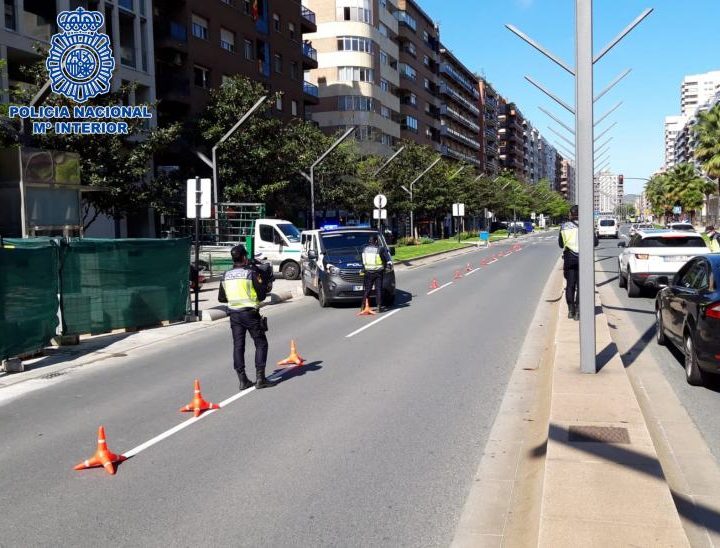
[655, 253, 720, 385]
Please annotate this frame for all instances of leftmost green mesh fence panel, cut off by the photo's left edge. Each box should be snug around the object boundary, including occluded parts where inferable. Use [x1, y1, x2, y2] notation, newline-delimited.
[0, 240, 58, 360]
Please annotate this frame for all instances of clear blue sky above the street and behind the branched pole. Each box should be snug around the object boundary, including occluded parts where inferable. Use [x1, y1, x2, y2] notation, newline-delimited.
[420, 0, 720, 197]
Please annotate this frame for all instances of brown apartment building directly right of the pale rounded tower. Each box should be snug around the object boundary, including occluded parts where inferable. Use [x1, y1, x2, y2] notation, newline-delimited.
[396, 0, 442, 151]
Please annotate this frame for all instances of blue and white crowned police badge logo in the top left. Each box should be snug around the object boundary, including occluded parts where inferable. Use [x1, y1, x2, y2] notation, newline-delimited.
[45, 8, 115, 103]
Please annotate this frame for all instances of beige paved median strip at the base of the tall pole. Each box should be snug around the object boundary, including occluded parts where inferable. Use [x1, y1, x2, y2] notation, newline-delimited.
[538, 294, 689, 547]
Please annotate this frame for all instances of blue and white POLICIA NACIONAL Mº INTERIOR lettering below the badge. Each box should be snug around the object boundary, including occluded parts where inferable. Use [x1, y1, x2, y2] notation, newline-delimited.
[8, 105, 152, 135]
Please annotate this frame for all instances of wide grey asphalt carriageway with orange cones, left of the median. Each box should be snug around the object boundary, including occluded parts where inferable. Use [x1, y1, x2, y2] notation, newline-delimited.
[0, 232, 560, 547]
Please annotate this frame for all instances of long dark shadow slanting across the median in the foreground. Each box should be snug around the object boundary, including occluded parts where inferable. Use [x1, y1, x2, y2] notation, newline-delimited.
[530, 424, 720, 532]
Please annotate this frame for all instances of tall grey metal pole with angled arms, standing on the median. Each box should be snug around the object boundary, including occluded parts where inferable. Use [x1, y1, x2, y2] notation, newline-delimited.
[575, 0, 597, 373]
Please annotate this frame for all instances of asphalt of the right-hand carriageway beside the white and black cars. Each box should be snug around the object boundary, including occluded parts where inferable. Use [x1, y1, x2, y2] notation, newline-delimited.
[595, 225, 720, 460]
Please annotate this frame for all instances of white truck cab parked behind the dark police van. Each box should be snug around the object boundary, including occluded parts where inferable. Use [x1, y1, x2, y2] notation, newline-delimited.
[254, 219, 302, 280]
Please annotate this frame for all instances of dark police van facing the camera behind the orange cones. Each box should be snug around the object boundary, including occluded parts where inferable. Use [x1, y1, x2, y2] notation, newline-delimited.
[301, 228, 395, 307]
